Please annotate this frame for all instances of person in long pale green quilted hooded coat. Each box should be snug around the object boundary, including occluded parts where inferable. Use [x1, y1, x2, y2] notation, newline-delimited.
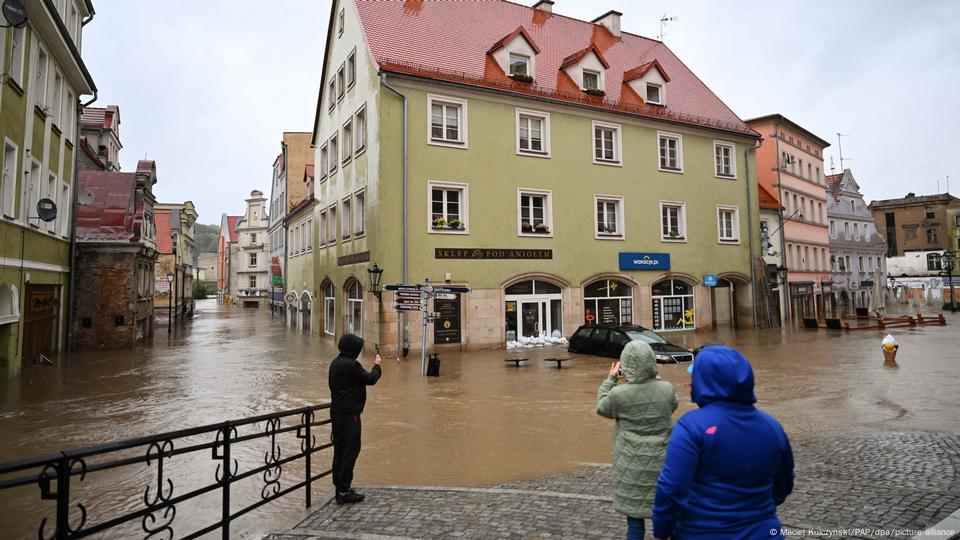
[597, 341, 679, 540]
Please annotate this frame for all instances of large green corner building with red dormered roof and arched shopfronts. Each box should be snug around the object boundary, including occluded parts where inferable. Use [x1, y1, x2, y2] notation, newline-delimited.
[313, 0, 759, 351]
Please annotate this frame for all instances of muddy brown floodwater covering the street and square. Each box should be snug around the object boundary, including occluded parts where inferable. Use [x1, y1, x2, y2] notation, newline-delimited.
[0, 300, 960, 538]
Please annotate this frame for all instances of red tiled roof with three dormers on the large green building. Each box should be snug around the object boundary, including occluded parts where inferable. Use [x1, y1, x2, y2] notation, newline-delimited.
[354, 0, 758, 136]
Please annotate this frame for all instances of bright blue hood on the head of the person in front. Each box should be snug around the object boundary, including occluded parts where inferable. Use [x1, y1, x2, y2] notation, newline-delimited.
[690, 346, 757, 407]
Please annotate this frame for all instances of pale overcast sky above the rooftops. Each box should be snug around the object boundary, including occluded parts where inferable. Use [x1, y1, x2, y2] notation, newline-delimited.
[83, 0, 960, 223]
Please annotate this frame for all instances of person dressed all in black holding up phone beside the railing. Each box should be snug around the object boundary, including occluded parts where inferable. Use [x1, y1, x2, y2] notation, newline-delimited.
[329, 334, 380, 504]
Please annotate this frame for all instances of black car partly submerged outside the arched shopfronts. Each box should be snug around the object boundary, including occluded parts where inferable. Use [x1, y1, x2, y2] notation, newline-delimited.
[567, 324, 693, 364]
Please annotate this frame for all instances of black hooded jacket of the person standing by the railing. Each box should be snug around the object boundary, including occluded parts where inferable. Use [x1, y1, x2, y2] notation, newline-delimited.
[329, 334, 380, 416]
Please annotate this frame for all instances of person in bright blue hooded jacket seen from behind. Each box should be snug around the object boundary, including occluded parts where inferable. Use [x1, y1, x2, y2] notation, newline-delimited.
[653, 346, 793, 540]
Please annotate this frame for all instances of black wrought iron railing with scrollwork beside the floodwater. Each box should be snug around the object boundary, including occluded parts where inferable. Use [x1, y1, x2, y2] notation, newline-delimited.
[0, 403, 332, 540]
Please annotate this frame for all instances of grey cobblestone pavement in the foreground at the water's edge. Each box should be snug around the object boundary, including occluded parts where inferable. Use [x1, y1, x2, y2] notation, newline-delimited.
[266, 433, 960, 540]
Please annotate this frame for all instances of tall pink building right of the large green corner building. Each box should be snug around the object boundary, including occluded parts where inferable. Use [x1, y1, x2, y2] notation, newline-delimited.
[747, 114, 832, 322]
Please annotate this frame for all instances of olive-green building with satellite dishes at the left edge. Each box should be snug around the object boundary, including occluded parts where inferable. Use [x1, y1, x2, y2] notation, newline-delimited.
[0, 0, 96, 376]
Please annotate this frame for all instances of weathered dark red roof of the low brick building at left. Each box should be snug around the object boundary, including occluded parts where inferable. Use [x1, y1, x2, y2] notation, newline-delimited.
[77, 171, 139, 242]
